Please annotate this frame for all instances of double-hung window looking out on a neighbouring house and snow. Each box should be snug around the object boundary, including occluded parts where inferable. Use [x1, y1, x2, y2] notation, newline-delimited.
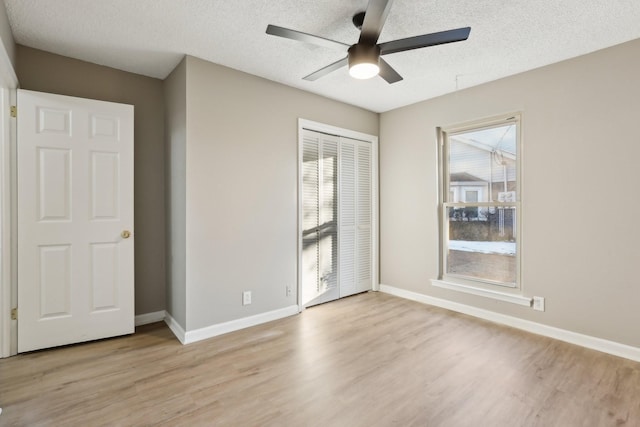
[439, 115, 521, 289]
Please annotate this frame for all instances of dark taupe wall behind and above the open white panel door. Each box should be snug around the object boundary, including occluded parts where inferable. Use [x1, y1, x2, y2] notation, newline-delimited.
[16, 45, 165, 314]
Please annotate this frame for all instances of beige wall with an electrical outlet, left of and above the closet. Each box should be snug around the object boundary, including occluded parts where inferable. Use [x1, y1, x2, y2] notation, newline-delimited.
[167, 57, 378, 331]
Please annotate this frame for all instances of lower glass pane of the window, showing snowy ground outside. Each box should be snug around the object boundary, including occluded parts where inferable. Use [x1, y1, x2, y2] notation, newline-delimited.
[446, 206, 517, 284]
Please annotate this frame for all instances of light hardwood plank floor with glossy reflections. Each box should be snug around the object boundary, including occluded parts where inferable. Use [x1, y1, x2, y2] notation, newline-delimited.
[0, 293, 640, 427]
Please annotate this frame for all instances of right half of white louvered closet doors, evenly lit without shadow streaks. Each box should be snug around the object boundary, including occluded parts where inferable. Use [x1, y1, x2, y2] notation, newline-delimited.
[339, 138, 372, 297]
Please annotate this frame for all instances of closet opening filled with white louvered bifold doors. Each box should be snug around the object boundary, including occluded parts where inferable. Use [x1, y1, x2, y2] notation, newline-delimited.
[298, 120, 378, 308]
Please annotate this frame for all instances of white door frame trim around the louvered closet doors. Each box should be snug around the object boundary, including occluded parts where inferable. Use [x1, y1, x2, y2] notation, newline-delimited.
[296, 118, 380, 312]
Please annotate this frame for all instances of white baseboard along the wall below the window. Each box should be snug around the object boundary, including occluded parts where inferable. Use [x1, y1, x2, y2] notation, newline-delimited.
[380, 285, 640, 362]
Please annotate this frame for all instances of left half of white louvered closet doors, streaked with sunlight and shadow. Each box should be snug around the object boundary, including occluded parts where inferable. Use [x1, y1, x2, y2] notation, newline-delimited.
[301, 130, 339, 306]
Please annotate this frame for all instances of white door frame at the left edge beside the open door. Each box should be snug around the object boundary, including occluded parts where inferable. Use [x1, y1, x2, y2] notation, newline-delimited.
[0, 43, 18, 358]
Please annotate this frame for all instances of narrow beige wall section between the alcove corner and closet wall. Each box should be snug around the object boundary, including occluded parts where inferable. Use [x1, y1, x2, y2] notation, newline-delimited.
[164, 59, 187, 327]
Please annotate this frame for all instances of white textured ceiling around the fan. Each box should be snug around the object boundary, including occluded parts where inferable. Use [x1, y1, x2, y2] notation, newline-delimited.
[5, 0, 640, 112]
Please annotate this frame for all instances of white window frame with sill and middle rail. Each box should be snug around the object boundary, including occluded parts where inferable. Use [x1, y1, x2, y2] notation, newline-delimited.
[431, 113, 531, 306]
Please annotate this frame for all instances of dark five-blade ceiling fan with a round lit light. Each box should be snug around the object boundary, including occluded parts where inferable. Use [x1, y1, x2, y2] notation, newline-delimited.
[267, 0, 471, 83]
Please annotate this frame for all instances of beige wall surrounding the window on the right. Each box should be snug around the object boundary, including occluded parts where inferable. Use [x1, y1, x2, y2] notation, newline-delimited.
[380, 40, 640, 347]
